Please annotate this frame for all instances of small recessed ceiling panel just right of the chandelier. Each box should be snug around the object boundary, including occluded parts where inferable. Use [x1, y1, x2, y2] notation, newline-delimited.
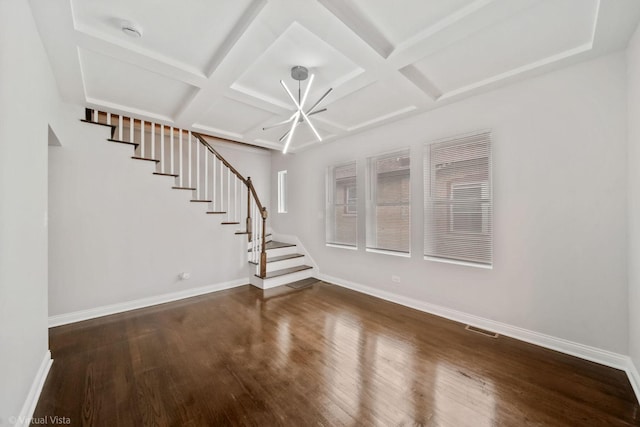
[318, 82, 415, 129]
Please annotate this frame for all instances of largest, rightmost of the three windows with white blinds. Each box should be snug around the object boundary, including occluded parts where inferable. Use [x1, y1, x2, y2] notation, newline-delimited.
[424, 132, 493, 266]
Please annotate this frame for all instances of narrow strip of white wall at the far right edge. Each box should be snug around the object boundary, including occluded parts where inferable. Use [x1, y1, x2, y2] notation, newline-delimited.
[627, 27, 640, 378]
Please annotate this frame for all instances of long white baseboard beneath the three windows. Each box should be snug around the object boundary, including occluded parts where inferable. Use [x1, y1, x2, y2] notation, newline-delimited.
[318, 274, 637, 372]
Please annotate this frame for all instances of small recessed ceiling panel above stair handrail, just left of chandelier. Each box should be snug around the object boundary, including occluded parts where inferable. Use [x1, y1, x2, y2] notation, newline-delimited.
[196, 98, 274, 134]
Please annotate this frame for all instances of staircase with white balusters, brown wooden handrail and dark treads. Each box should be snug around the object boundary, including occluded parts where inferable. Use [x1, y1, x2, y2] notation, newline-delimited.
[82, 108, 313, 289]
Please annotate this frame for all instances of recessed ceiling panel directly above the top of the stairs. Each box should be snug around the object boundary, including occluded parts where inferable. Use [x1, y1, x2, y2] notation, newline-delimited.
[79, 49, 196, 117]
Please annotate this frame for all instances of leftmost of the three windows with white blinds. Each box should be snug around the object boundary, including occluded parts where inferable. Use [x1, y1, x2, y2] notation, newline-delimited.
[326, 162, 358, 248]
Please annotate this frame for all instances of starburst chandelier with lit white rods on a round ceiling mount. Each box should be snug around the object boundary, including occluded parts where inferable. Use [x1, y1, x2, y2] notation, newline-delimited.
[262, 65, 333, 154]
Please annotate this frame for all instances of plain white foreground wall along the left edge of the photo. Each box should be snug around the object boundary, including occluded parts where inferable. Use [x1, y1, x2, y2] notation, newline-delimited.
[0, 0, 58, 424]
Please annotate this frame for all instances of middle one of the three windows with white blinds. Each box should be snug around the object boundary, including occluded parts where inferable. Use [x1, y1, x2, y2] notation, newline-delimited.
[367, 150, 411, 255]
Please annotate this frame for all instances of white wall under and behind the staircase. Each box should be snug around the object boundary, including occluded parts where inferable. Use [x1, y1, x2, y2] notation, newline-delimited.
[49, 107, 271, 315]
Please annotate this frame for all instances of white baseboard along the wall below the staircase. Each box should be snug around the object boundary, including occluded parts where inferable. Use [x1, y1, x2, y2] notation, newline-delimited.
[49, 279, 249, 328]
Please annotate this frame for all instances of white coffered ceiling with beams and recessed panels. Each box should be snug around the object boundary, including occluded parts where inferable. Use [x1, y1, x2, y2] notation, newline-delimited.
[31, 0, 640, 151]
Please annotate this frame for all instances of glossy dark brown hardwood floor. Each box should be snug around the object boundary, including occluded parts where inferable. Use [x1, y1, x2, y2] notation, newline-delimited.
[34, 282, 640, 427]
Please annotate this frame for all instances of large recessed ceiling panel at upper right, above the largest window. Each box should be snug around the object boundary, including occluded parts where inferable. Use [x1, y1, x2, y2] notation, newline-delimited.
[414, 0, 598, 93]
